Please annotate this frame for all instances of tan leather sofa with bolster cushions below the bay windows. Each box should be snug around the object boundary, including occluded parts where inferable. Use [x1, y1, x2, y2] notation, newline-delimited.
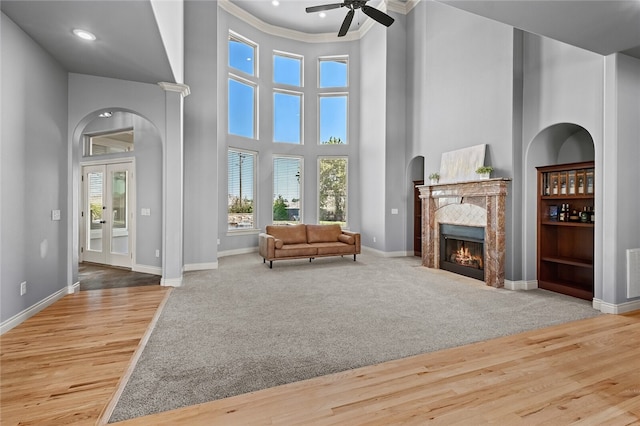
[258, 224, 360, 268]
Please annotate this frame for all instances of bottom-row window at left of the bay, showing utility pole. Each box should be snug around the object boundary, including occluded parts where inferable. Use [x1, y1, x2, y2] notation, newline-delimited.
[227, 149, 257, 230]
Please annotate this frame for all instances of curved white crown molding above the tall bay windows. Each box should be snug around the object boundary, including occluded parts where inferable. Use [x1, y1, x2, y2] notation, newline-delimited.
[218, 0, 400, 43]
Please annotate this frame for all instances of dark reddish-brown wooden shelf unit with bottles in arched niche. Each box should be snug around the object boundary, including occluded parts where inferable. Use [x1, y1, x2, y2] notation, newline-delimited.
[537, 161, 595, 300]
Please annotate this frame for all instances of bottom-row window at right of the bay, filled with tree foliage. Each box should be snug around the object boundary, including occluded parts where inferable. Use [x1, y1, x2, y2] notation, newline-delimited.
[318, 157, 347, 227]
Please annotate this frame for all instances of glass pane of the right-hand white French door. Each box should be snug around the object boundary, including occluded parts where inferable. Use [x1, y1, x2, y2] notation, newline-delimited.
[108, 171, 129, 254]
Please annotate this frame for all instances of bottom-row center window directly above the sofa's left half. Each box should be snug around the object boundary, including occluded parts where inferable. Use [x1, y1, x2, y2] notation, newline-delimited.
[273, 157, 302, 223]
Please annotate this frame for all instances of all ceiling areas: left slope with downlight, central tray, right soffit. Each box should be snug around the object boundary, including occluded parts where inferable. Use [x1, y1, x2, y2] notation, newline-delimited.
[0, 0, 640, 83]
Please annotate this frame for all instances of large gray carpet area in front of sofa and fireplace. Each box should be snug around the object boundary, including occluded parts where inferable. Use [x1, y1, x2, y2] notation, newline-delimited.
[110, 254, 599, 422]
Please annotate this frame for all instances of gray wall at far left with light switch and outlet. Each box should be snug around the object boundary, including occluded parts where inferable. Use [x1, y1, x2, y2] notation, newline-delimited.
[0, 13, 70, 322]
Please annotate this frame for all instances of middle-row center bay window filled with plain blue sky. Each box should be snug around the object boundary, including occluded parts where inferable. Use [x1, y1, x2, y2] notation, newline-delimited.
[273, 90, 302, 144]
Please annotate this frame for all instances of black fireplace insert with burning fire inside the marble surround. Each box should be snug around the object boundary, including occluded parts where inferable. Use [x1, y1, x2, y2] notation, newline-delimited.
[440, 224, 484, 281]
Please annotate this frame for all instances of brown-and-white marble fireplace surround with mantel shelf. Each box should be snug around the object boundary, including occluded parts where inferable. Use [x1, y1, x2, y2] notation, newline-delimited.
[419, 178, 511, 287]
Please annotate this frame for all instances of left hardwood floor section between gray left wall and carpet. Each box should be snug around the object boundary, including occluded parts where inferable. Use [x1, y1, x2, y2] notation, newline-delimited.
[0, 286, 170, 426]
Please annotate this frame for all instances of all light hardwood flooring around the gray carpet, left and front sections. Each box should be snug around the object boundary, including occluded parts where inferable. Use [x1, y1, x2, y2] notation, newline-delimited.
[0, 286, 640, 426]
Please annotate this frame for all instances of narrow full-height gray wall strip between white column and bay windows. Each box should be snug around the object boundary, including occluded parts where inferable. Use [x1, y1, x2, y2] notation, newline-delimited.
[184, 1, 224, 269]
